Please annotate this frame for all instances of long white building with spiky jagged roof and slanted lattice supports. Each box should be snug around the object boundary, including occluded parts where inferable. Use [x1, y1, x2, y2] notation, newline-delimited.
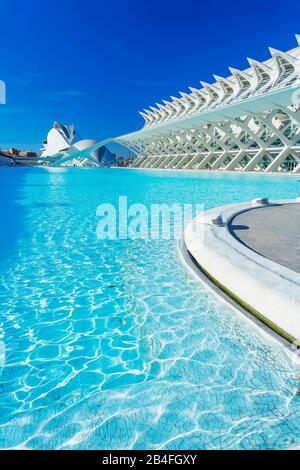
[113, 35, 300, 173]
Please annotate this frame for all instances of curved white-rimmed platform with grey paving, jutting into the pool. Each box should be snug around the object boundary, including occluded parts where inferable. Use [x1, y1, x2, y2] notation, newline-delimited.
[184, 199, 300, 347]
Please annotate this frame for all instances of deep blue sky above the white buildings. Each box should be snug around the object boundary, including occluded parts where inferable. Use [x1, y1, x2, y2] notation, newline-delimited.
[0, 0, 300, 149]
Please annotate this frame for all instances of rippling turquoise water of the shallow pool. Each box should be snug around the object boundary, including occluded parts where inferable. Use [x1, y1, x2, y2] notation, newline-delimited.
[0, 168, 300, 449]
